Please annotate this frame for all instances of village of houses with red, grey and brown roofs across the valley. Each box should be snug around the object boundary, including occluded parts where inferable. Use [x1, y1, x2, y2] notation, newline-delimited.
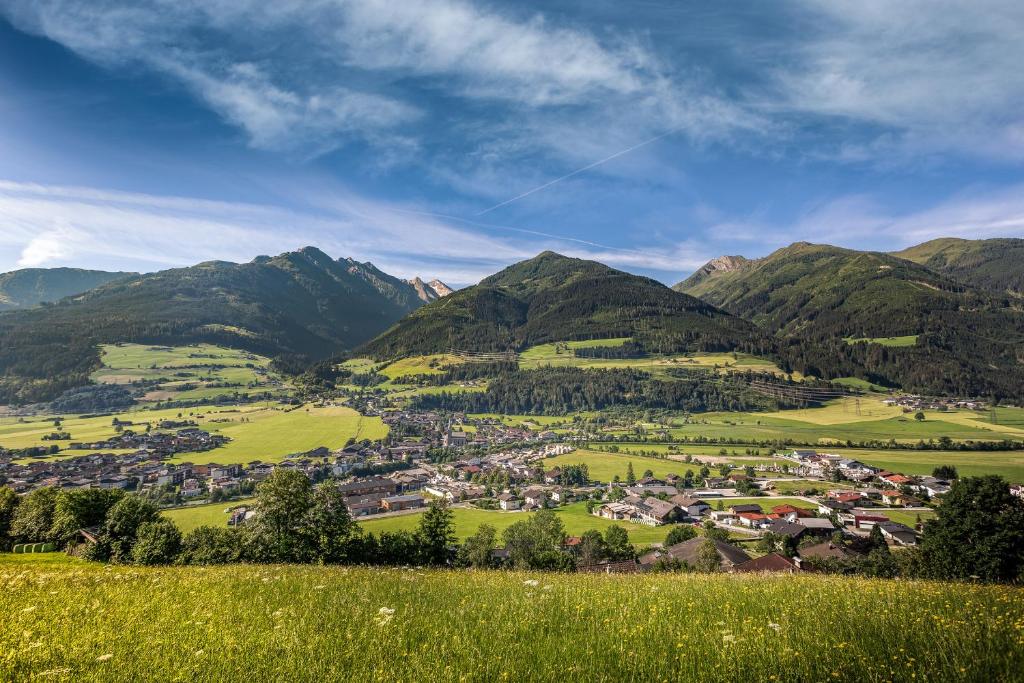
[6, 407, 1024, 572]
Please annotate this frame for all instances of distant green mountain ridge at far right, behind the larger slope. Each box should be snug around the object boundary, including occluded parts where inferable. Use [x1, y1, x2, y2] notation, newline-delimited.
[893, 238, 1024, 295]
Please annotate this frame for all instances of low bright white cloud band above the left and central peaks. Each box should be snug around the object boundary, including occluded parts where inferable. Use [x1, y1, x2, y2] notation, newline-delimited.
[0, 181, 704, 285]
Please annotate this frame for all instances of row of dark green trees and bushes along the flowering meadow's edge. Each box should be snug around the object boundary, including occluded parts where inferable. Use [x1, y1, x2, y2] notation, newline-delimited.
[0, 470, 1024, 583]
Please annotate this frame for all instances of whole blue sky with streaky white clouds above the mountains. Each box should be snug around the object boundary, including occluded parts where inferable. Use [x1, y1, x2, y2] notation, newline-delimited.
[0, 0, 1024, 285]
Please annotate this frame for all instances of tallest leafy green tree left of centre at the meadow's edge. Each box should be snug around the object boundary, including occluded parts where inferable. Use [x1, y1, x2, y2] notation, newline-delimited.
[244, 468, 315, 562]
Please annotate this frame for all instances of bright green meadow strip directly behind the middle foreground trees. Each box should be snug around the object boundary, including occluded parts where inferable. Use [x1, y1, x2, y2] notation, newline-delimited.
[359, 503, 672, 546]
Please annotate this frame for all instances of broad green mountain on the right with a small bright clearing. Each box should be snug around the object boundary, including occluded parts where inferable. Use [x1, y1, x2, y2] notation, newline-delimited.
[674, 243, 1024, 397]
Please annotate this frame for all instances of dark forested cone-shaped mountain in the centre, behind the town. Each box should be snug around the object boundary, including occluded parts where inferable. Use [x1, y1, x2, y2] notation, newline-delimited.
[362, 252, 758, 358]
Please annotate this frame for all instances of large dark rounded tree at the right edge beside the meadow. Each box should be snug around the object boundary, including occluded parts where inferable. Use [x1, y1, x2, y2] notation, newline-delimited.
[920, 475, 1024, 582]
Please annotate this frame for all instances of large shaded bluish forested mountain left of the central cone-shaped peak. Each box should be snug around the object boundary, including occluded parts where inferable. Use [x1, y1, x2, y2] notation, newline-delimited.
[0, 247, 422, 403]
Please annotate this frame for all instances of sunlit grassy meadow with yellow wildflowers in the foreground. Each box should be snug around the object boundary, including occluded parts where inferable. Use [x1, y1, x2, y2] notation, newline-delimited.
[0, 563, 1024, 683]
